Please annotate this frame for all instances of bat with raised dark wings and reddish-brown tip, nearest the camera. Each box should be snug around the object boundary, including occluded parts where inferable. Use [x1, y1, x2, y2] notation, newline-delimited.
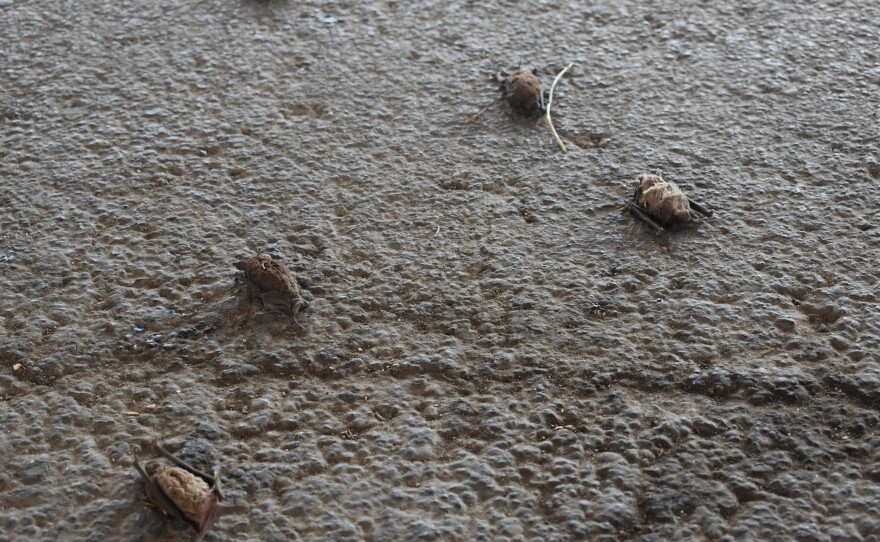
[134, 442, 247, 542]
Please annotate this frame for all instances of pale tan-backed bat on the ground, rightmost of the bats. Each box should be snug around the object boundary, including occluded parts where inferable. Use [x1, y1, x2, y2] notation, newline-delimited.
[627, 174, 712, 232]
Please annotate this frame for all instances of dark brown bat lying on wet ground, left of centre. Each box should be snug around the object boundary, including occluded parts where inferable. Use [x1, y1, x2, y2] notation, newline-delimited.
[235, 255, 309, 328]
